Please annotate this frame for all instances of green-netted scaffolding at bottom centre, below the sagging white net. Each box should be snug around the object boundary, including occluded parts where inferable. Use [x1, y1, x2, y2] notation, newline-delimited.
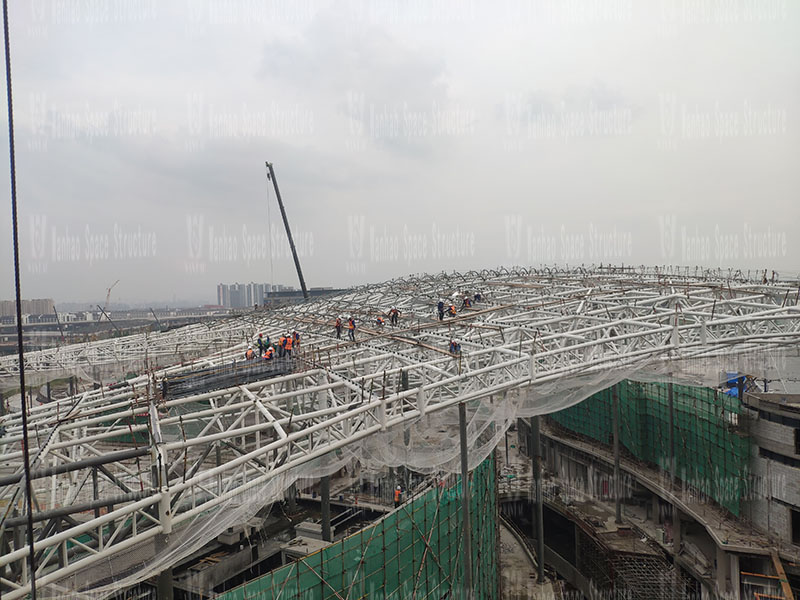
[217, 454, 498, 600]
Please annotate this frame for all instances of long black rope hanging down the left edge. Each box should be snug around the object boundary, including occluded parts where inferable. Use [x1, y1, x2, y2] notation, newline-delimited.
[3, 0, 36, 600]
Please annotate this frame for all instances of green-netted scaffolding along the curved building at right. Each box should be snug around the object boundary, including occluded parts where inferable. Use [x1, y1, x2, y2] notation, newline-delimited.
[551, 380, 750, 516]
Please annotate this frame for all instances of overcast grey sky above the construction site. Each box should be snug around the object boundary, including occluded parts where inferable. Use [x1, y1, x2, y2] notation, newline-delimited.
[0, 0, 800, 303]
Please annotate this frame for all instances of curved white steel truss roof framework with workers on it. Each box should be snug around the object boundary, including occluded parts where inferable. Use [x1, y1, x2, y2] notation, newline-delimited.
[0, 268, 800, 600]
